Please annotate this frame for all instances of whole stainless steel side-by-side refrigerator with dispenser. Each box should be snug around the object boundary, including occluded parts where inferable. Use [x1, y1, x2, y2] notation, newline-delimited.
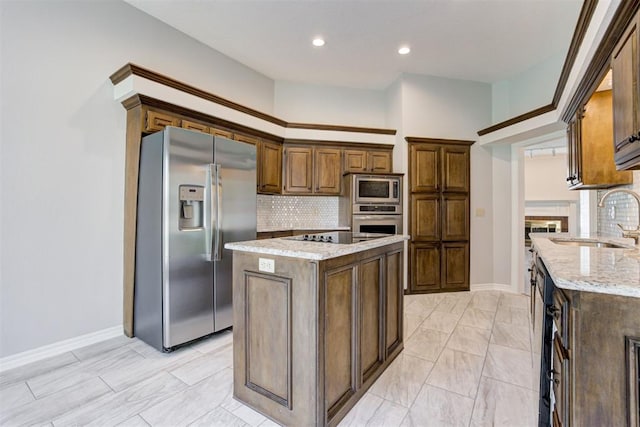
[133, 127, 256, 351]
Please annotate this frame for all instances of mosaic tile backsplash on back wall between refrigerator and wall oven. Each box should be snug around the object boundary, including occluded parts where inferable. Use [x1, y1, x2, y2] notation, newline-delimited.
[258, 194, 338, 231]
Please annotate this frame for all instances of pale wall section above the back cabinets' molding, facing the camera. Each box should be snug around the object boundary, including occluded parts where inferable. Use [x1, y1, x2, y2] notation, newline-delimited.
[274, 81, 386, 127]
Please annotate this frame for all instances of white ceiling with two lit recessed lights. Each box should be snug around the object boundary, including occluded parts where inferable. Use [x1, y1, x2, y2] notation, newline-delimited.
[125, 0, 582, 89]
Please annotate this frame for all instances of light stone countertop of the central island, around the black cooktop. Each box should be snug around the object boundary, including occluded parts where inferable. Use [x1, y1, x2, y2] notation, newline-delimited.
[224, 234, 409, 261]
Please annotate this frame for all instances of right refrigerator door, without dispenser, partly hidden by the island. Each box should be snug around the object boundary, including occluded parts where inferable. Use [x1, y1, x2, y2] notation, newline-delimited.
[214, 138, 257, 331]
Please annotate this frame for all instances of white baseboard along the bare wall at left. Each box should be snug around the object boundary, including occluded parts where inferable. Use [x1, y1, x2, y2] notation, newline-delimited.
[0, 325, 124, 372]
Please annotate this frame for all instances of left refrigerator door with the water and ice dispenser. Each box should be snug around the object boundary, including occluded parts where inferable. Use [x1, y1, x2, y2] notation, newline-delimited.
[164, 127, 214, 348]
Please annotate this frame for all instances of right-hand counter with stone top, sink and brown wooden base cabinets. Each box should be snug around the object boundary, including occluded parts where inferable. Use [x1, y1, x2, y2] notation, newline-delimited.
[531, 233, 640, 426]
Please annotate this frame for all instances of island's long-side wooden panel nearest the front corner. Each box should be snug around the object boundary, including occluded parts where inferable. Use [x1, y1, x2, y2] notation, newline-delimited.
[324, 266, 356, 414]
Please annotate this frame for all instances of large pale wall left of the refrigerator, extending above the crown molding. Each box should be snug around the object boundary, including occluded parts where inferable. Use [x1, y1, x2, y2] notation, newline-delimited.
[0, 1, 273, 357]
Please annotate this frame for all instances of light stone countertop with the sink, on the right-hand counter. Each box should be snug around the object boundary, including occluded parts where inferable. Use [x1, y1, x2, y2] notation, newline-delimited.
[530, 233, 640, 298]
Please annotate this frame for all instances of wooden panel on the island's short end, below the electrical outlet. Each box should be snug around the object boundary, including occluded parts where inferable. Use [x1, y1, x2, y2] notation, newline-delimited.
[245, 274, 291, 407]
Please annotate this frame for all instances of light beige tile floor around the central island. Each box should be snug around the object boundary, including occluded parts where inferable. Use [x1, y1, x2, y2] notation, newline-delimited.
[0, 291, 536, 427]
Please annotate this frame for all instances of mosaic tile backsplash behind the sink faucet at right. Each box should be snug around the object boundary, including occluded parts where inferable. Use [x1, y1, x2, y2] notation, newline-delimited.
[598, 171, 640, 237]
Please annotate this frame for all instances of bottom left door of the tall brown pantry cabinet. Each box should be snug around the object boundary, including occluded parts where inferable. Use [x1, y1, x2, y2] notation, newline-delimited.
[409, 243, 440, 292]
